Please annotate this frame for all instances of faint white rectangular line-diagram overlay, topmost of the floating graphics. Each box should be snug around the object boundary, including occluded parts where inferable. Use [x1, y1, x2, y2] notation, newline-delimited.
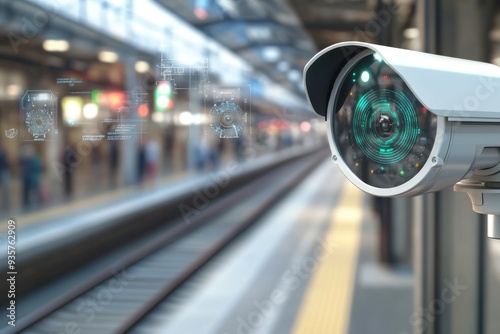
[158, 54, 210, 94]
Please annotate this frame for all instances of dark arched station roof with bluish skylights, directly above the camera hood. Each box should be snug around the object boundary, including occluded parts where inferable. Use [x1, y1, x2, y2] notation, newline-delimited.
[156, 0, 415, 91]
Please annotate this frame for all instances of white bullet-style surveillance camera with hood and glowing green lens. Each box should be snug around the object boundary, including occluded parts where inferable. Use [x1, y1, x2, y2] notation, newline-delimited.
[304, 42, 500, 237]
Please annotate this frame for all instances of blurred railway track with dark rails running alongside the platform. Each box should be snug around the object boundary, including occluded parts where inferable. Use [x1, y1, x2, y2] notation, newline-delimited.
[5, 150, 325, 334]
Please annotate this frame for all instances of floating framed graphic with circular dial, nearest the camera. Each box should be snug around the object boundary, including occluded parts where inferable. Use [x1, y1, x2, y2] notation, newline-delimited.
[209, 86, 251, 138]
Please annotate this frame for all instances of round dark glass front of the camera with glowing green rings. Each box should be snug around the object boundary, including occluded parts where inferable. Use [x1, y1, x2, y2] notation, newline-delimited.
[333, 54, 437, 188]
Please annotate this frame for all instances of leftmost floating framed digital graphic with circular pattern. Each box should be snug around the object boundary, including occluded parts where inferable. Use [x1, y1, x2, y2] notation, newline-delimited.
[20, 90, 57, 141]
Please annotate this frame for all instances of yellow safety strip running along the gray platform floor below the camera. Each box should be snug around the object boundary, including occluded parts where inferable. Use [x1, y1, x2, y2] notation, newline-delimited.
[292, 183, 362, 334]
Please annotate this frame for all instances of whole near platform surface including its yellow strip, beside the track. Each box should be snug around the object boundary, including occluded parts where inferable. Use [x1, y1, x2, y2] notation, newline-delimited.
[134, 162, 413, 334]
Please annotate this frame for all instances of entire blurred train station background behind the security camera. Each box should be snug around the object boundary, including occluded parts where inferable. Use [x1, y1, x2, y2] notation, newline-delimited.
[0, 0, 500, 334]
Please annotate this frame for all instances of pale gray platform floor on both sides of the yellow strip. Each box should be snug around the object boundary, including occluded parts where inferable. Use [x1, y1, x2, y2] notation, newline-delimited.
[137, 162, 413, 334]
